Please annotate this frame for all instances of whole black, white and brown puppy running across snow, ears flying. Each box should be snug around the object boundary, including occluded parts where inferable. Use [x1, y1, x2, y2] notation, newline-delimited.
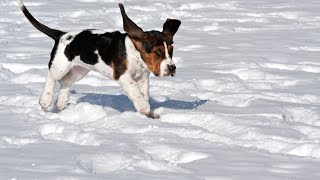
[18, 0, 181, 118]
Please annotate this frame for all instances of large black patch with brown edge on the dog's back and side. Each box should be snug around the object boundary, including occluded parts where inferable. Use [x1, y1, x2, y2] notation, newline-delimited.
[64, 30, 127, 80]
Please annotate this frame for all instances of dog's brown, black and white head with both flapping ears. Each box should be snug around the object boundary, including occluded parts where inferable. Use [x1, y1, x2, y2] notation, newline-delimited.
[119, 4, 181, 77]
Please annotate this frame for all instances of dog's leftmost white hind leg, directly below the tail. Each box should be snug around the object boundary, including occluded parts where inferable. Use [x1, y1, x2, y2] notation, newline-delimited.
[39, 71, 56, 110]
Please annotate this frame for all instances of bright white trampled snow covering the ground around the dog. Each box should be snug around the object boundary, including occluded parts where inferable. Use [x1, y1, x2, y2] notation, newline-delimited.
[0, 0, 320, 180]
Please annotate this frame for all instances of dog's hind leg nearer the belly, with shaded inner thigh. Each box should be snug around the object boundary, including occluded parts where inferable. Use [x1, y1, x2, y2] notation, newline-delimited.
[57, 66, 90, 110]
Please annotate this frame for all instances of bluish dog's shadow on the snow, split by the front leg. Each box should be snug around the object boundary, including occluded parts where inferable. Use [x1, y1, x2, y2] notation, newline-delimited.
[77, 93, 208, 112]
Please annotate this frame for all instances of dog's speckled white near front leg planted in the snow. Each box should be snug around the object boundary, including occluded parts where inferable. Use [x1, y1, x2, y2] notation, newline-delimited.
[119, 74, 160, 119]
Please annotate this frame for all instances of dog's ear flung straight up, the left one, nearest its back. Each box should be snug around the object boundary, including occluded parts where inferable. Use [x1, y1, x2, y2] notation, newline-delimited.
[119, 3, 144, 40]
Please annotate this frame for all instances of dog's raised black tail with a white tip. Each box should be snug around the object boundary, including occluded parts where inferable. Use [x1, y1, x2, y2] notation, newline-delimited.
[18, 0, 65, 41]
